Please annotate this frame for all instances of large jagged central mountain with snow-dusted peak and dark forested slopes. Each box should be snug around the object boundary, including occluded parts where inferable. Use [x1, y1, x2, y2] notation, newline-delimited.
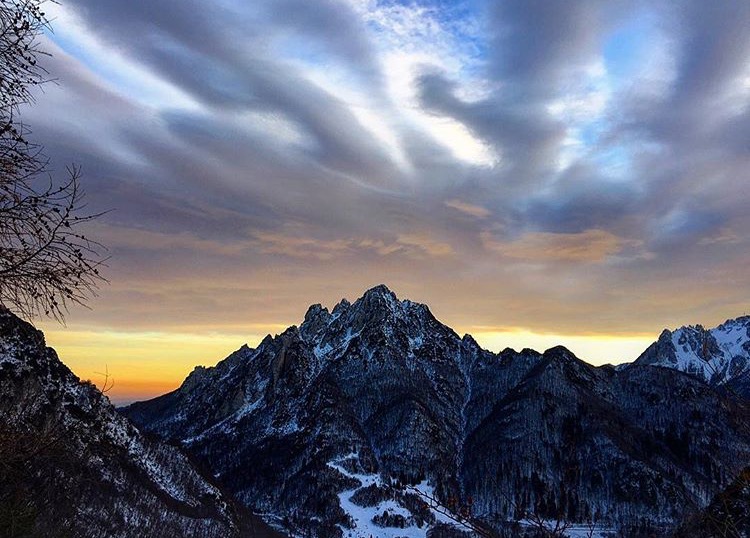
[121, 286, 750, 538]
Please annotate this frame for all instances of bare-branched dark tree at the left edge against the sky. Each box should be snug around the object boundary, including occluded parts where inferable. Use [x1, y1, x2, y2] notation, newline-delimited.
[0, 0, 103, 319]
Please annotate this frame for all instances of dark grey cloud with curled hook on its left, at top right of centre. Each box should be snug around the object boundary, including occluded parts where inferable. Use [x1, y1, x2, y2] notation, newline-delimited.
[419, 1, 622, 202]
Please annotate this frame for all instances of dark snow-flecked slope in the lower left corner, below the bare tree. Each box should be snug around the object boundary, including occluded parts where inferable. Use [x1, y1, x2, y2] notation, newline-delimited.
[0, 307, 282, 538]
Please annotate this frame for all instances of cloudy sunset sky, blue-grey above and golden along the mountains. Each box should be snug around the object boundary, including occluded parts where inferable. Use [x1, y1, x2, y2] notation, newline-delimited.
[22, 0, 750, 401]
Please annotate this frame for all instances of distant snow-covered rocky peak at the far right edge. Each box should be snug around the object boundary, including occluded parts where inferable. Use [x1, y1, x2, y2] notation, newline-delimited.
[635, 316, 750, 385]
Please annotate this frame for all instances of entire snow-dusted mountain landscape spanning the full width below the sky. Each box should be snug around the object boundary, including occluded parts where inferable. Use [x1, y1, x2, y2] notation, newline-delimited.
[0, 286, 750, 538]
